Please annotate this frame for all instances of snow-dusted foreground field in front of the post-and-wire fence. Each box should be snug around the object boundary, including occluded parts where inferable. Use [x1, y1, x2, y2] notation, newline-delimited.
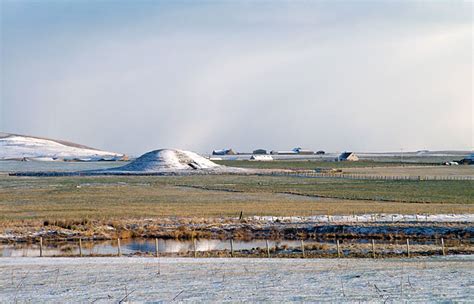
[0, 256, 474, 303]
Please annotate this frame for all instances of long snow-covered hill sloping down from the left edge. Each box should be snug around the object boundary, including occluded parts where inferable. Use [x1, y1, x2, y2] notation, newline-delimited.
[0, 133, 126, 161]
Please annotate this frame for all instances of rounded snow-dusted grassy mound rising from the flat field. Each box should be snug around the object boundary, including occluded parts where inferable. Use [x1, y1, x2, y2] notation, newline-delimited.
[107, 149, 219, 172]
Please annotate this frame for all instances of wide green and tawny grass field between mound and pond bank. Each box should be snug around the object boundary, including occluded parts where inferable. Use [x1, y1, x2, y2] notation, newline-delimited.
[0, 175, 474, 225]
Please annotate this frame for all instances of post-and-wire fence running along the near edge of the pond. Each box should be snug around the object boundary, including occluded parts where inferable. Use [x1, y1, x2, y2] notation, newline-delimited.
[4, 237, 474, 258]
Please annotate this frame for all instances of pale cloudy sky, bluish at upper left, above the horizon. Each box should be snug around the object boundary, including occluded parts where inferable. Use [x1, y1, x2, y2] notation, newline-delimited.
[0, 0, 474, 155]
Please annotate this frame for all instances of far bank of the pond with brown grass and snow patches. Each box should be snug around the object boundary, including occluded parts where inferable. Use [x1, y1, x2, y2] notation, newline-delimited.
[0, 218, 474, 243]
